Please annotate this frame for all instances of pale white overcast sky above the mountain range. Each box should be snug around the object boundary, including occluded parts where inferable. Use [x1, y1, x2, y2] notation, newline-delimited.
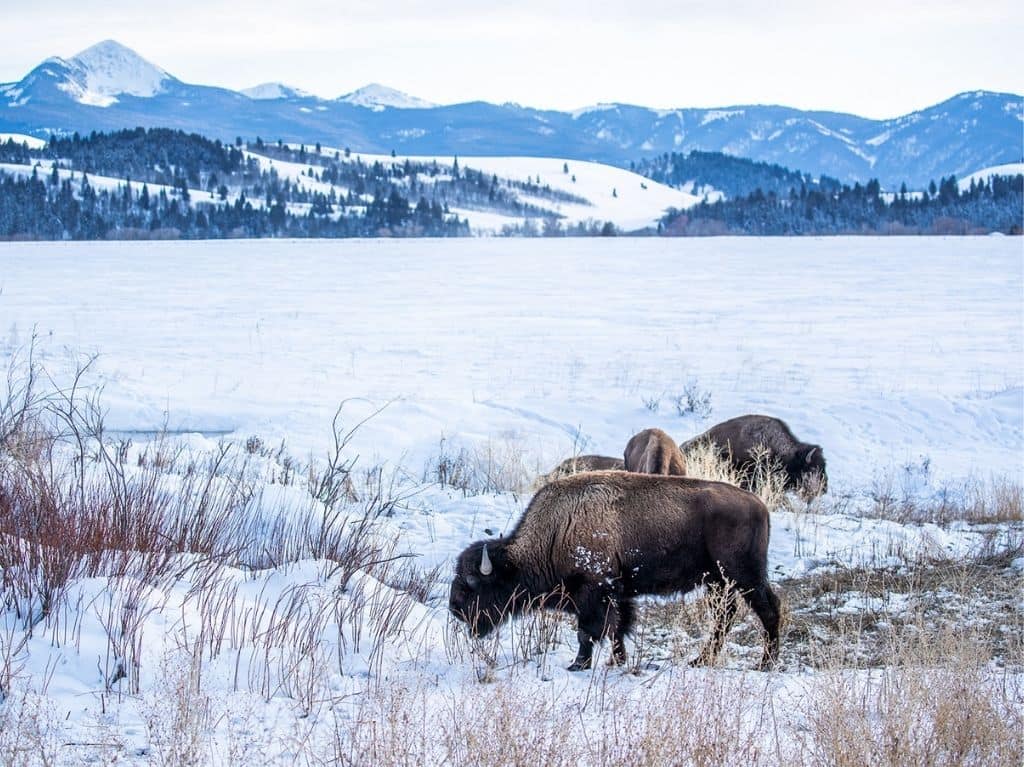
[0, 0, 1024, 118]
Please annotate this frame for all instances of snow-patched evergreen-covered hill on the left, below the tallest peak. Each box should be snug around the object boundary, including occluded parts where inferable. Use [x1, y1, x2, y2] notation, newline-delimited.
[0, 128, 475, 240]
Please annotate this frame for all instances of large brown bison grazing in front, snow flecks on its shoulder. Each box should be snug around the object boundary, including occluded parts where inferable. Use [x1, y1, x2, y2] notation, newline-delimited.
[449, 471, 779, 671]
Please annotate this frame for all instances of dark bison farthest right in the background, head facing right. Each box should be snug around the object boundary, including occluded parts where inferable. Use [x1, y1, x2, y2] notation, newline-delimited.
[683, 416, 828, 499]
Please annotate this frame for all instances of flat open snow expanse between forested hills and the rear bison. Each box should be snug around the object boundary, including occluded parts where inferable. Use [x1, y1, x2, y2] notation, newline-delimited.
[0, 236, 1024, 486]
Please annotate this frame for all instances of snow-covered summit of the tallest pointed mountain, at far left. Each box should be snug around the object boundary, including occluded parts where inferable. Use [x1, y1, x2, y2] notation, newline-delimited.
[57, 40, 172, 106]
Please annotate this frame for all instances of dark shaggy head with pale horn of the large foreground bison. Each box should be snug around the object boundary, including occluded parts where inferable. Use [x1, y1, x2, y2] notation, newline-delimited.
[449, 541, 524, 637]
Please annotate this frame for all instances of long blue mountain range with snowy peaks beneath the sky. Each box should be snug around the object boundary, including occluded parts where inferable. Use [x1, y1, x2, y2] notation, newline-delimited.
[0, 41, 1024, 188]
